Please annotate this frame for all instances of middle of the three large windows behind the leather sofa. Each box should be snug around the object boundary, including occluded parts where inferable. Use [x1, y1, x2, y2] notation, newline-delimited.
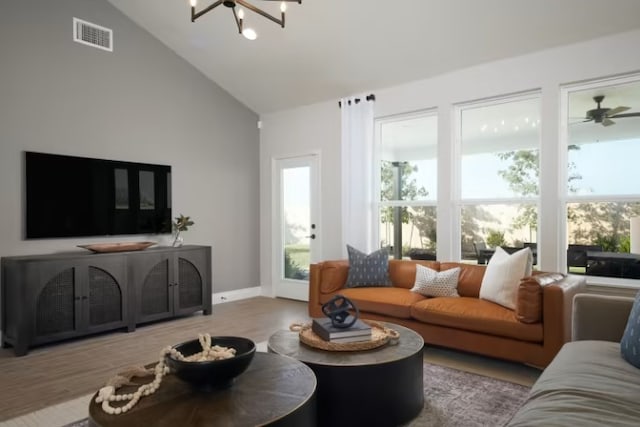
[458, 94, 540, 264]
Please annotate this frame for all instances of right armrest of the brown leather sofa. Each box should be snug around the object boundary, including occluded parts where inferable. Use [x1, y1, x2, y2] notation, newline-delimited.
[542, 275, 587, 361]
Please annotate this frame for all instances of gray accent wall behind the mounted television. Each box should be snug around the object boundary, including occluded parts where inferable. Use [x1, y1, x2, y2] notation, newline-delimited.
[0, 0, 259, 292]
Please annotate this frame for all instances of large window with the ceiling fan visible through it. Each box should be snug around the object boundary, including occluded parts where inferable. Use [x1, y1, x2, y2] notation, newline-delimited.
[563, 76, 640, 279]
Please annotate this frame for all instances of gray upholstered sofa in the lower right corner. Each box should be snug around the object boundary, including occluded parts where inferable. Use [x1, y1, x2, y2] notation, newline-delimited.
[508, 294, 640, 427]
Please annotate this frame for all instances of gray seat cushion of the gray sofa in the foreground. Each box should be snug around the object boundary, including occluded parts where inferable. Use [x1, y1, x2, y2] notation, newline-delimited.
[507, 341, 640, 427]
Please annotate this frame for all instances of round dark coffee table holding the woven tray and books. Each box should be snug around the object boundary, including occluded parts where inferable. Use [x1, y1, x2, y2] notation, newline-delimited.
[268, 323, 424, 426]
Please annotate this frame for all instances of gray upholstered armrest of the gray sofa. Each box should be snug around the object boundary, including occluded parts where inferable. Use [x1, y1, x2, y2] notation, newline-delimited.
[571, 294, 634, 342]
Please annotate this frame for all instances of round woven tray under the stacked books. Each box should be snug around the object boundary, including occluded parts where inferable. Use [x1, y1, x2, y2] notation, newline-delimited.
[289, 320, 400, 351]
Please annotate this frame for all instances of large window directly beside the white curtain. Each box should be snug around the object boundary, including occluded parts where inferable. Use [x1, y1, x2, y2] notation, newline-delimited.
[376, 113, 438, 259]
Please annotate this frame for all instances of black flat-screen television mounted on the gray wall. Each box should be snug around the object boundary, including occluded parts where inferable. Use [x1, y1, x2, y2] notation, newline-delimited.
[25, 151, 171, 239]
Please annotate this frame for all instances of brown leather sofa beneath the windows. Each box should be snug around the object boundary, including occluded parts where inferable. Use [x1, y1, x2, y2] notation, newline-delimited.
[309, 260, 586, 367]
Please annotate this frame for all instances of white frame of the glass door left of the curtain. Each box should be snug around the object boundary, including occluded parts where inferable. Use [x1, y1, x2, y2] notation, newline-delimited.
[271, 152, 322, 301]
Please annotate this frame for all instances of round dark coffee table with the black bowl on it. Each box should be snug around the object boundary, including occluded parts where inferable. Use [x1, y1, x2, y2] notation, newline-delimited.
[89, 353, 316, 427]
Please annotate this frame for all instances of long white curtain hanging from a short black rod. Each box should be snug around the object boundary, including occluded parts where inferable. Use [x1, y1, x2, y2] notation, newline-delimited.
[340, 95, 375, 257]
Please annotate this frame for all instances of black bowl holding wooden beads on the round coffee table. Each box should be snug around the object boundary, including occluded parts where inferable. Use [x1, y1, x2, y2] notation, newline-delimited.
[165, 337, 256, 390]
